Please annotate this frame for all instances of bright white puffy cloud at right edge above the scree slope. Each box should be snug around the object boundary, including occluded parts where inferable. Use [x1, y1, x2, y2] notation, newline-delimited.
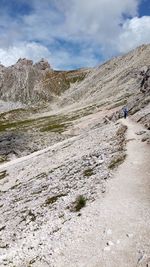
[118, 16, 150, 53]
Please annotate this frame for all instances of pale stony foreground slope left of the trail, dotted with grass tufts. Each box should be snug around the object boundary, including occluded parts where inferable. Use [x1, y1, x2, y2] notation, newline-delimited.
[0, 110, 124, 266]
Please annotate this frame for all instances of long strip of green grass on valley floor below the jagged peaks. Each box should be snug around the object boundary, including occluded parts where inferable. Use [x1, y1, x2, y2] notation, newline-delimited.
[0, 105, 102, 136]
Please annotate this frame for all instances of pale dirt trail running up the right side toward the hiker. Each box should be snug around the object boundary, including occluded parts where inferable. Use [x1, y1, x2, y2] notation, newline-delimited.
[56, 119, 150, 267]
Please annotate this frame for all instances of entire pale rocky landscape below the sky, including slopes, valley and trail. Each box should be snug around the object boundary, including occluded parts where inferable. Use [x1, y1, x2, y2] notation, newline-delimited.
[0, 45, 150, 267]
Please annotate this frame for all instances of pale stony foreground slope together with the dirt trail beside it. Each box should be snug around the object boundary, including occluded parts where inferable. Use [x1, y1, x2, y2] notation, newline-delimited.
[0, 119, 150, 267]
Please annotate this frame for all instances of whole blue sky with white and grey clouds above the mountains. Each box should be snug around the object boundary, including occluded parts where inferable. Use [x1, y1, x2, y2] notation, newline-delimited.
[0, 0, 150, 70]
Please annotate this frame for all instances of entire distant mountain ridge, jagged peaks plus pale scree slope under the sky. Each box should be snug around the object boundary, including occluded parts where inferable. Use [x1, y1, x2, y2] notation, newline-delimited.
[0, 45, 150, 107]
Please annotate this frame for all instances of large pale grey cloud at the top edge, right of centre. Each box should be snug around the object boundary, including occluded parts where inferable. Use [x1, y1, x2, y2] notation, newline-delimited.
[60, 0, 139, 42]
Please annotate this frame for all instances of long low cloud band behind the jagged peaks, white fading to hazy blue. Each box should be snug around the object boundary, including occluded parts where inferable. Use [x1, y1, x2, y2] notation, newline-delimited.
[0, 40, 98, 69]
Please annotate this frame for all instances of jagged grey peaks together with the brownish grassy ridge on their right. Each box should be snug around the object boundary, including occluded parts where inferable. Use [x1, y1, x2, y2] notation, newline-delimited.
[0, 58, 88, 104]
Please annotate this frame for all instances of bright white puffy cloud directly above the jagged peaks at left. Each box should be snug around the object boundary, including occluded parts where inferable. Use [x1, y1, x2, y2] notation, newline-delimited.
[0, 43, 51, 66]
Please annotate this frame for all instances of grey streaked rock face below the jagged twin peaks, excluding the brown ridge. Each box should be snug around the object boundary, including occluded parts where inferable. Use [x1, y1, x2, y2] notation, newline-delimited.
[0, 59, 50, 103]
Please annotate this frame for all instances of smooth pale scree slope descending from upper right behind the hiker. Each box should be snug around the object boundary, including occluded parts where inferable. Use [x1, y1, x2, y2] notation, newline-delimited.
[60, 45, 150, 109]
